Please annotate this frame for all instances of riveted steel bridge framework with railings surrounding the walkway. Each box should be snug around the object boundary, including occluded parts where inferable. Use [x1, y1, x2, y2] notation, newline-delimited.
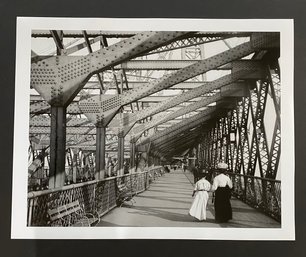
[28, 30, 281, 226]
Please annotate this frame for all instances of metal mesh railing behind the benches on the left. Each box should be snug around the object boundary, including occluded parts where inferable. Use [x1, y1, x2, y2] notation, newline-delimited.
[27, 166, 164, 226]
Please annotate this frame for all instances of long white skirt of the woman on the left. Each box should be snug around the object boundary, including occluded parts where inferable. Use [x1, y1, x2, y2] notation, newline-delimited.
[189, 191, 209, 220]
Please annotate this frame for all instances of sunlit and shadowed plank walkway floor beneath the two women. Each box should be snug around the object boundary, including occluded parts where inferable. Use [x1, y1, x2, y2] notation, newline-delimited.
[97, 170, 281, 228]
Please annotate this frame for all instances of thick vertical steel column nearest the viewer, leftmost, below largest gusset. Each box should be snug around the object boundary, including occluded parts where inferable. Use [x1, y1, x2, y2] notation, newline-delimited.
[49, 106, 66, 188]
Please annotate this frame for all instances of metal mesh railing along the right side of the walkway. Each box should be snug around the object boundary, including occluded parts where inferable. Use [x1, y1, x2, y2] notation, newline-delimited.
[214, 172, 281, 222]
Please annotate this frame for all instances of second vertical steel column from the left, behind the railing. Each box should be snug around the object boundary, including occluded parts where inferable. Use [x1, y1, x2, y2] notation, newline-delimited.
[95, 125, 106, 180]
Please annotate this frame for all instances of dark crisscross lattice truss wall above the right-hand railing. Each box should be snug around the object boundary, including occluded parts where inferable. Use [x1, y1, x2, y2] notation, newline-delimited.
[200, 67, 281, 179]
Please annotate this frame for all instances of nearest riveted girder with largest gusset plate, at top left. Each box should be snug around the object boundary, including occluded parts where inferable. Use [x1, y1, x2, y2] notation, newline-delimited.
[31, 32, 186, 106]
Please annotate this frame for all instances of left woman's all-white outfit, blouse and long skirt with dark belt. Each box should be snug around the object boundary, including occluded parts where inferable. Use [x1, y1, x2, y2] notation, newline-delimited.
[189, 178, 211, 221]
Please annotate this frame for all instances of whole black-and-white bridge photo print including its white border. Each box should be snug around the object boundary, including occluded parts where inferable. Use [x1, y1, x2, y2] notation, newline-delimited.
[12, 17, 295, 240]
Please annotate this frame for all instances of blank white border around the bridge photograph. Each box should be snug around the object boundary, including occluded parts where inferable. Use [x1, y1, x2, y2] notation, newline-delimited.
[11, 17, 295, 240]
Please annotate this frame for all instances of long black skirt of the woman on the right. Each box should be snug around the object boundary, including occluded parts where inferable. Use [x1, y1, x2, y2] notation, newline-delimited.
[214, 186, 232, 222]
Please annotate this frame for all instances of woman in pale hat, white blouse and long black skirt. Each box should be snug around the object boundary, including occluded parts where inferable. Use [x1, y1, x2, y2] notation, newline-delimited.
[212, 163, 233, 223]
